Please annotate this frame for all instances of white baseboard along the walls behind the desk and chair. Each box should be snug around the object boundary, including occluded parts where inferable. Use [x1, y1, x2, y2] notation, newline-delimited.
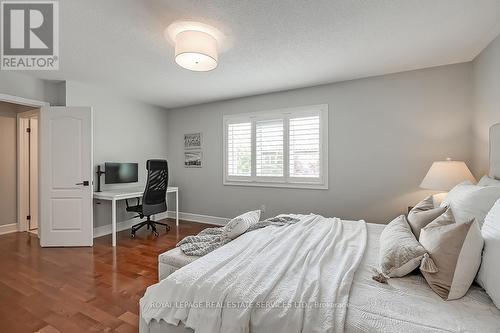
[92, 211, 230, 238]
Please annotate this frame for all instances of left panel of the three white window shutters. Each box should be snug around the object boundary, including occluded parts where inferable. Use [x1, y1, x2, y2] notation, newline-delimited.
[227, 122, 252, 176]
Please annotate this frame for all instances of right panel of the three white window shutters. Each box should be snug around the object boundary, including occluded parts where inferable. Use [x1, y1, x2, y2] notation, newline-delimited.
[289, 115, 321, 178]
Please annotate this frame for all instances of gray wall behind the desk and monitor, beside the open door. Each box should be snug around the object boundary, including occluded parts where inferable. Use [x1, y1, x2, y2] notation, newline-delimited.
[65, 81, 168, 226]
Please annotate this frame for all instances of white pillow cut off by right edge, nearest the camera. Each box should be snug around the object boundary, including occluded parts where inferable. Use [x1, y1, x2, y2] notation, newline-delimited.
[476, 200, 500, 309]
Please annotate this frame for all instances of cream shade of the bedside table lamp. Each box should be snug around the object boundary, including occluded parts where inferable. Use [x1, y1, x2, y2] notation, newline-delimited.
[420, 160, 476, 191]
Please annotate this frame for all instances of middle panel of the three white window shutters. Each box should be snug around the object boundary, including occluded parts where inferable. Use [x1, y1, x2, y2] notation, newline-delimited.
[255, 119, 284, 177]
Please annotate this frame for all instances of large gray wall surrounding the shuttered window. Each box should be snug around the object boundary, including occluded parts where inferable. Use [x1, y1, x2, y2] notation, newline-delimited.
[168, 63, 472, 223]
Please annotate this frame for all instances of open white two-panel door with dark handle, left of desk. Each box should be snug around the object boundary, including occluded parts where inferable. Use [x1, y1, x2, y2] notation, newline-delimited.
[39, 107, 93, 247]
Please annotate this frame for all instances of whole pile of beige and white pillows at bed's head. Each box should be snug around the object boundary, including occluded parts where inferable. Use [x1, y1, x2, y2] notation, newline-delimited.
[380, 177, 500, 302]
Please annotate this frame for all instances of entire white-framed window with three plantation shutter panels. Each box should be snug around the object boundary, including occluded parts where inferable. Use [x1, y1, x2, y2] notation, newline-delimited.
[224, 105, 328, 189]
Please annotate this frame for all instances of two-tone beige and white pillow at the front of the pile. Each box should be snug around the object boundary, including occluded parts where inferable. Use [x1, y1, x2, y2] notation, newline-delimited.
[420, 209, 484, 300]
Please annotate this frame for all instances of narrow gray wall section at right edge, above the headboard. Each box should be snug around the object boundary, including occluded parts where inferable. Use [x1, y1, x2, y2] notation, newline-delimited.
[473, 36, 500, 177]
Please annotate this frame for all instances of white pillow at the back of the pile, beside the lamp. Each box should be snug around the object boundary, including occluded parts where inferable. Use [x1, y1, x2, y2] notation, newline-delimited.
[441, 183, 500, 227]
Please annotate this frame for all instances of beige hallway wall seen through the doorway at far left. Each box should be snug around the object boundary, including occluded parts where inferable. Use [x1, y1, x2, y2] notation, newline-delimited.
[0, 102, 17, 225]
